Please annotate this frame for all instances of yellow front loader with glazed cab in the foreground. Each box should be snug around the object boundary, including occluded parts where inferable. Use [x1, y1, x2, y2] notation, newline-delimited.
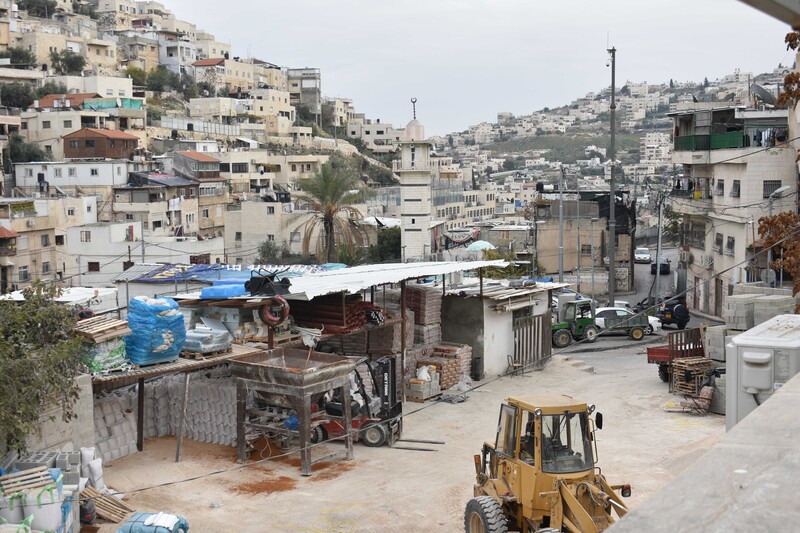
[464, 396, 631, 533]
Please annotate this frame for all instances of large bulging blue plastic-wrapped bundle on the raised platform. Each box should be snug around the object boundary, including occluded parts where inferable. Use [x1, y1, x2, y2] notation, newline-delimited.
[125, 296, 186, 366]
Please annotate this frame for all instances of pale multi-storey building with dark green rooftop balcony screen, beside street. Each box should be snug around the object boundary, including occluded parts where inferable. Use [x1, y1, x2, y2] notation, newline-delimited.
[671, 106, 797, 316]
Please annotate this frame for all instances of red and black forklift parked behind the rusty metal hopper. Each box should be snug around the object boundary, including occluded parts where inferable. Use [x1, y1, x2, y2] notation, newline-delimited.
[311, 357, 403, 447]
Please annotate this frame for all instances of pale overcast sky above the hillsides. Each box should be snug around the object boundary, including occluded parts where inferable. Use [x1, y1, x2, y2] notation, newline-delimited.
[163, 0, 794, 135]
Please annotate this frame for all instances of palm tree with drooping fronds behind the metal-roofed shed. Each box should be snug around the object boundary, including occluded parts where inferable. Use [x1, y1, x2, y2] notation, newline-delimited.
[297, 158, 367, 263]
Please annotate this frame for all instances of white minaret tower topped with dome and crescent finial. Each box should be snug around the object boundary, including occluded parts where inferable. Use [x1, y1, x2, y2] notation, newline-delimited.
[393, 98, 433, 261]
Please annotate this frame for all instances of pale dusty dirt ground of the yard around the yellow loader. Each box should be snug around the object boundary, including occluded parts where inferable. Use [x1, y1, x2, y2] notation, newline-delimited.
[102, 348, 724, 533]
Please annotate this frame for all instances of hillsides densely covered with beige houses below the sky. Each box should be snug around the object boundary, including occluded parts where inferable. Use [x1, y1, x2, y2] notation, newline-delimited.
[0, 0, 789, 306]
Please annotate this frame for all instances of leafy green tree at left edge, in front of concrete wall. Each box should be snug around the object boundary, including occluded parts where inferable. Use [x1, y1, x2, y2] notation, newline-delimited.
[0, 282, 83, 450]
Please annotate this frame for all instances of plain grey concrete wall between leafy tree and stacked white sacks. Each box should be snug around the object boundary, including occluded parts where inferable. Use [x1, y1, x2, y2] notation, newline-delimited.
[26, 374, 94, 451]
